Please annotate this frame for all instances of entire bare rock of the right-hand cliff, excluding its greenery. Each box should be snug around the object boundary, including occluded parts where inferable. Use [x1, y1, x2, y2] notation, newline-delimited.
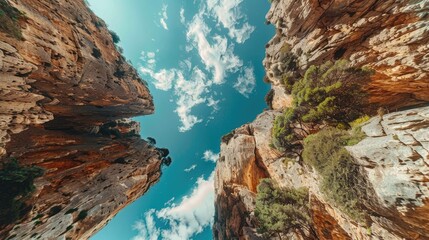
[213, 0, 429, 239]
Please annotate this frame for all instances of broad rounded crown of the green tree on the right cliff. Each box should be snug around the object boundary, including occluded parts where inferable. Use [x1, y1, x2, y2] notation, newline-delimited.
[292, 60, 369, 125]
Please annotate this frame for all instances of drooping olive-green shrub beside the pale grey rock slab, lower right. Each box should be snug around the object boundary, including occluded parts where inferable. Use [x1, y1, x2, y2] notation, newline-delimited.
[302, 128, 366, 222]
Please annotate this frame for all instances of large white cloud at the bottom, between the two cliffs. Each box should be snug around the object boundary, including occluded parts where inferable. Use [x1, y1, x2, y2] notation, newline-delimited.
[133, 173, 214, 240]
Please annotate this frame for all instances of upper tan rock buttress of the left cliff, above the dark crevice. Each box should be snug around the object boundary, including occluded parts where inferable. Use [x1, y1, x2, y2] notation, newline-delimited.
[0, 0, 154, 156]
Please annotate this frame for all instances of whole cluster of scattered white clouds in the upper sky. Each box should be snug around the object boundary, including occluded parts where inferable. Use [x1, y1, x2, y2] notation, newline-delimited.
[140, 0, 255, 132]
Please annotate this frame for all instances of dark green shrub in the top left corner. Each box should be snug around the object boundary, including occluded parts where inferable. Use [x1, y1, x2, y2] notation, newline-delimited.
[0, 0, 23, 40]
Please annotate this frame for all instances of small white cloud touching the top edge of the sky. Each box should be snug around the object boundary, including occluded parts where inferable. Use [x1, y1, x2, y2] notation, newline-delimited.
[207, 0, 255, 43]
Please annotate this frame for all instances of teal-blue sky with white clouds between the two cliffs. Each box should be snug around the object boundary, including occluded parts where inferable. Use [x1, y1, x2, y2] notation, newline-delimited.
[89, 0, 274, 240]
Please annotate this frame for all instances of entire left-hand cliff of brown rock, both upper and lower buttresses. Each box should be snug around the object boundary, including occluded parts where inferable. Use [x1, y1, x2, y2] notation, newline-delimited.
[0, 0, 161, 239]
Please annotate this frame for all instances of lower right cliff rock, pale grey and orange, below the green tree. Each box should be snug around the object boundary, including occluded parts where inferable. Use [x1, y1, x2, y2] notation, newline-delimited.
[214, 107, 429, 239]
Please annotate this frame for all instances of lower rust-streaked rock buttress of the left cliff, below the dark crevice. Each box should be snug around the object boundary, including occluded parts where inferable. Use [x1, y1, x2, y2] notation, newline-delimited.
[4, 120, 161, 239]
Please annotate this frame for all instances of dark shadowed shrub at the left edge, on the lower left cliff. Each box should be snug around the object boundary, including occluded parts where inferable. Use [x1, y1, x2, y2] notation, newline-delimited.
[0, 159, 43, 226]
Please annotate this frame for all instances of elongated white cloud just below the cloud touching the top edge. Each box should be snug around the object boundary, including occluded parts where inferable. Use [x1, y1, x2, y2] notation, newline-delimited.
[186, 12, 243, 84]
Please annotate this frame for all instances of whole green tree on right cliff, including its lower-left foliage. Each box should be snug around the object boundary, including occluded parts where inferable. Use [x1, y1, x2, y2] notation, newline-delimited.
[272, 61, 371, 155]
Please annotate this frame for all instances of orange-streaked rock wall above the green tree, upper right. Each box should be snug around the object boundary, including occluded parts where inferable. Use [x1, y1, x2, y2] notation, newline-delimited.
[264, 0, 429, 109]
